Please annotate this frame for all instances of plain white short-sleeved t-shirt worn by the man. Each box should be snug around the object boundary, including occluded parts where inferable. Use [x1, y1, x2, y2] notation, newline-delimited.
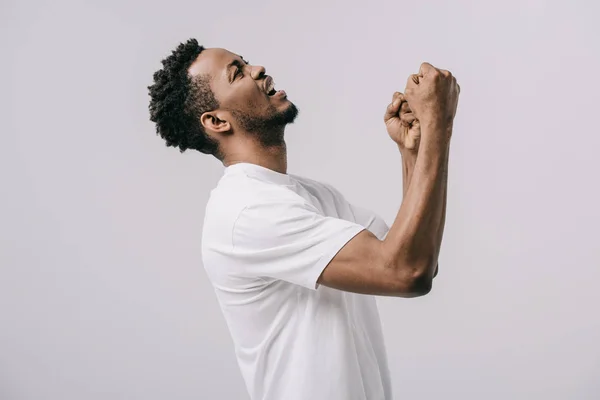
[202, 163, 392, 400]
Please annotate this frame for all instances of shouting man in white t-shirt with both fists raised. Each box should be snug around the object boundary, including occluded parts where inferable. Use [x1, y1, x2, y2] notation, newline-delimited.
[149, 39, 459, 400]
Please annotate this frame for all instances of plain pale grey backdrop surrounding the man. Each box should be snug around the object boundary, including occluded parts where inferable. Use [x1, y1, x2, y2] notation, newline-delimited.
[0, 0, 600, 400]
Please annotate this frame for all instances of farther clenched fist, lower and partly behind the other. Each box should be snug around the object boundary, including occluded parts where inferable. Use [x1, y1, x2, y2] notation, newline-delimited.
[383, 92, 421, 153]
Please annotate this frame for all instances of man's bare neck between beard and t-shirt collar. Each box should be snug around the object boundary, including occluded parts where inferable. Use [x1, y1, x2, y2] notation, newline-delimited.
[223, 135, 287, 174]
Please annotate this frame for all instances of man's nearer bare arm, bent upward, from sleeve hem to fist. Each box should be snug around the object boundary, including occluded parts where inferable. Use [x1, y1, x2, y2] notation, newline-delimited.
[318, 63, 459, 297]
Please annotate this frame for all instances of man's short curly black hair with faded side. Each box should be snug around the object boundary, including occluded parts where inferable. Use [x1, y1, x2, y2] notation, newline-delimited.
[148, 39, 222, 160]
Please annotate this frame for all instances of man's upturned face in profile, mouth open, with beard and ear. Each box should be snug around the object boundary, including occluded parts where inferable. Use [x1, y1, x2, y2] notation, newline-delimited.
[189, 49, 298, 145]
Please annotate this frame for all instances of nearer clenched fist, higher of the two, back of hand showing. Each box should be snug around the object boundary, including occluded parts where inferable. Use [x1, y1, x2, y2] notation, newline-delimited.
[404, 63, 460, 132]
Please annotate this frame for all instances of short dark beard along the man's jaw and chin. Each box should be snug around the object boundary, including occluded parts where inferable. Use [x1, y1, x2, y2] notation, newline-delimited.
[232, 103, 298, 147]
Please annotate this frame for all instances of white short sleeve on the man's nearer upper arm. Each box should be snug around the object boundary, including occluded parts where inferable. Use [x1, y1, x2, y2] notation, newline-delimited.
[232, 197, 364, 289]
